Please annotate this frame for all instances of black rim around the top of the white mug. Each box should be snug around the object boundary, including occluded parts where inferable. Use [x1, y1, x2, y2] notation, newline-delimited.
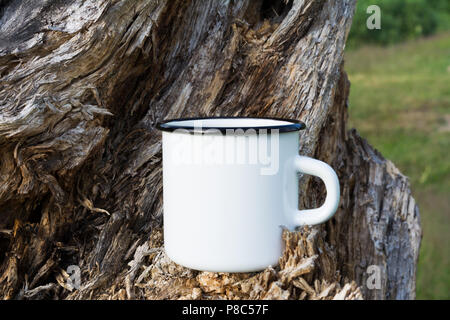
[156, 116, 306, 133]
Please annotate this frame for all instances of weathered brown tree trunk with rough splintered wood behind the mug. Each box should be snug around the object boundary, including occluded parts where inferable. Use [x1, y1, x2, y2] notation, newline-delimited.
[0, 0, 421, 299]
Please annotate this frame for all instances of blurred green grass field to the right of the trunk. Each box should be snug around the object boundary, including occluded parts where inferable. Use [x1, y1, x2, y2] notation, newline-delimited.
[345, 32, 450, 299]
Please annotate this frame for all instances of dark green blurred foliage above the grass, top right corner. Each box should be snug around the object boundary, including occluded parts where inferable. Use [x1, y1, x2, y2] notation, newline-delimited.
[347, 0, 450, 48]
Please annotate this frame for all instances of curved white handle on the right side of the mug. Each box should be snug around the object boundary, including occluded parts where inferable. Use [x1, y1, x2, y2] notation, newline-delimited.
[294, 155, 340, 226]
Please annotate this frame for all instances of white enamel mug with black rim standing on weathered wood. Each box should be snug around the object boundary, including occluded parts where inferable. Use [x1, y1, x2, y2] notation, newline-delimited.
[157, 117, 339, 272]
